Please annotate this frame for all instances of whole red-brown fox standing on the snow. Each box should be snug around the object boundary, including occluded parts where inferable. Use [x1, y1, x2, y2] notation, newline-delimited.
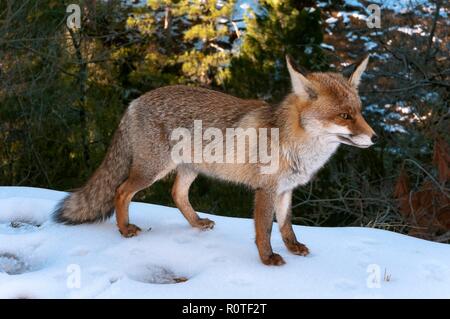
[53, 56, 377, 266]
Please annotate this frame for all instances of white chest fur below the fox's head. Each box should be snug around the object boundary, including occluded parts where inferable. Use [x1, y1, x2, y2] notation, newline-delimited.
[278, 137, 339, 194]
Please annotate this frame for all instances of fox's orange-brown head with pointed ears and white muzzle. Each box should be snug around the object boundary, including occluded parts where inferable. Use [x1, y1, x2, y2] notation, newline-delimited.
[286, 57, 377, 148]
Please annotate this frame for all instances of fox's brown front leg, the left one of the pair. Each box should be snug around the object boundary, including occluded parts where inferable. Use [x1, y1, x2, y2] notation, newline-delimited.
[254, 189, 285, 266]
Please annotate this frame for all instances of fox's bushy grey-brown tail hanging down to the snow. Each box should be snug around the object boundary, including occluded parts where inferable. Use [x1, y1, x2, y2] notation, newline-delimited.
[53, 126, 131, 225]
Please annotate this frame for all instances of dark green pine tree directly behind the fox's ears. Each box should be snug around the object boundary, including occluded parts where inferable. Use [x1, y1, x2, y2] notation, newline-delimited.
[227, 0, 325, 101]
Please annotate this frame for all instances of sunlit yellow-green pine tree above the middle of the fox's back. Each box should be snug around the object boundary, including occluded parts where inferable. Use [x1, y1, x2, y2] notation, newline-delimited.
[130, 0, 236, 86]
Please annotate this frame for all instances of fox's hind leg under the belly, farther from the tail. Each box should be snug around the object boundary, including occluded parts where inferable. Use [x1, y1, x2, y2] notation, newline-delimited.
[172, 168, 214, 230]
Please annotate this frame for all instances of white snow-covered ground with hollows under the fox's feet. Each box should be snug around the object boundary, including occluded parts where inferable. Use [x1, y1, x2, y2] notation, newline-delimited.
[0, 187, 450, 298]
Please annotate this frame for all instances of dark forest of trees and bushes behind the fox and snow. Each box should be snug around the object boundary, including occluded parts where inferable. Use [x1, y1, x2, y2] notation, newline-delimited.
[0, 0, 450, 242]
